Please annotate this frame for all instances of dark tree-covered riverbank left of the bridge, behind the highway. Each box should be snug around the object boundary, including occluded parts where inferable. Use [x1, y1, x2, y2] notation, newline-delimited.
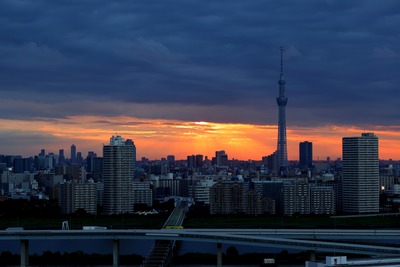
[0, 199, 174, 230]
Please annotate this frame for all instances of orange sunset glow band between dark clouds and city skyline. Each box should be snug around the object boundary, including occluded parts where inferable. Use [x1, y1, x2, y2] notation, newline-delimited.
[0, 116, 400, 160]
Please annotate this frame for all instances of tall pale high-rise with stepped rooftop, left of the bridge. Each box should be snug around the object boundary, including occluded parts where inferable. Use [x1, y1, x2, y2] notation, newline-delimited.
[103, 136, 136, 214]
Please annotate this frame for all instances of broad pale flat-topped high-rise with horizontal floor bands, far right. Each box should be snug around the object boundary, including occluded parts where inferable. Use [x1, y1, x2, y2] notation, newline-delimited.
[342, 133, 379, 213]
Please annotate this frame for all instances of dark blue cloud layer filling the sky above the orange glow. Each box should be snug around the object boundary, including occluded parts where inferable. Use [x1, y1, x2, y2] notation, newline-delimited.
[0, 0, 400, 125]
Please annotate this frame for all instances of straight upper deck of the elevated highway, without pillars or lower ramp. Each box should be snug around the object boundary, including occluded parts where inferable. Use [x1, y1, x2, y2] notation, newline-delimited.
[0, 229, 400, 242]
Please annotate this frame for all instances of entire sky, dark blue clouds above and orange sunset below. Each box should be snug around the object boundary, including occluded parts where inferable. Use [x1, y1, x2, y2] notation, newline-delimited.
[0, 0, 400, 160]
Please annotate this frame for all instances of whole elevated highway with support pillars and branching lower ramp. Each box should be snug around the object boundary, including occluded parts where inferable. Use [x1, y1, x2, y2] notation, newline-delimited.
[0, 229, 400, 266]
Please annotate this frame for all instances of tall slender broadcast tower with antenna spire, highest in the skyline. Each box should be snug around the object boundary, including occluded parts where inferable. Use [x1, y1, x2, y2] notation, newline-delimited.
[276, 47, 288, 174]
